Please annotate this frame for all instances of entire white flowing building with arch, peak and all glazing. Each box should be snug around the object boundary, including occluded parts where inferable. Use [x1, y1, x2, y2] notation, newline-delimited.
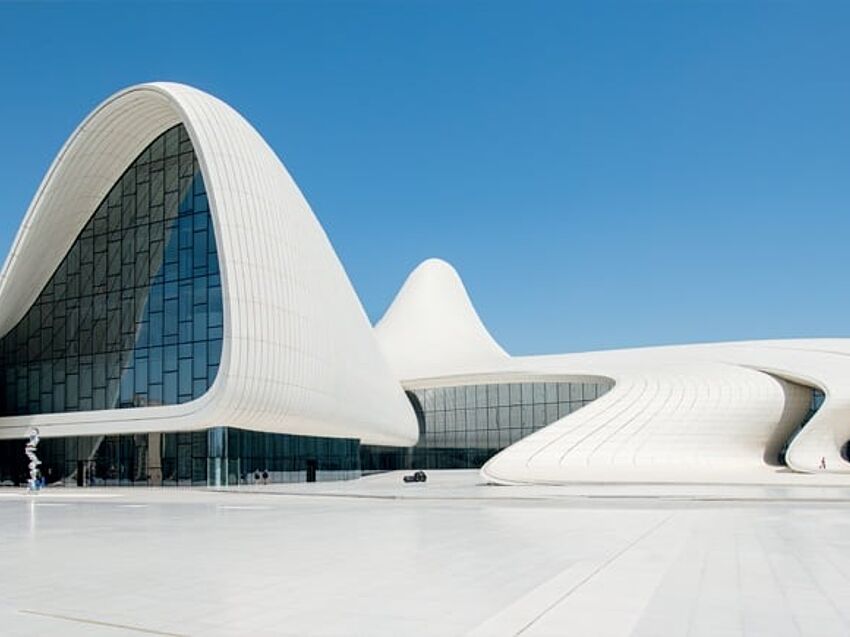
[0, 83, 850, 484]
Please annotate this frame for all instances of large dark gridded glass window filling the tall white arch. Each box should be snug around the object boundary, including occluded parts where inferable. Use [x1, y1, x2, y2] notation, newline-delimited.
[0, 125, 223, 414]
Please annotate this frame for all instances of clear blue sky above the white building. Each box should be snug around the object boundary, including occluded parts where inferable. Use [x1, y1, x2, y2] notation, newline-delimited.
[0, 0, 850, 354]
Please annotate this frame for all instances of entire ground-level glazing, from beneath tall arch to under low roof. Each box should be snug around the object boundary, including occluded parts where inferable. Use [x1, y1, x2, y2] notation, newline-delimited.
[0, 379, 613, 486]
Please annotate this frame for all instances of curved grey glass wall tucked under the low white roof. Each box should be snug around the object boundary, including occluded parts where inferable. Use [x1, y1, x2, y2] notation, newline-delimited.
[360, 379, 613, 471]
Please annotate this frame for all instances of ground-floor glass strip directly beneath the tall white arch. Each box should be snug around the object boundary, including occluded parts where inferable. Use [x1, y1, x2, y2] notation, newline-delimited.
[0, 427, 360, 486]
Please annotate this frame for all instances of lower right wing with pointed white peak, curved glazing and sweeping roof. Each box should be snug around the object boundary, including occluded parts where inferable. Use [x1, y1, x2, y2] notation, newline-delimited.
[376, 260, 850, 484]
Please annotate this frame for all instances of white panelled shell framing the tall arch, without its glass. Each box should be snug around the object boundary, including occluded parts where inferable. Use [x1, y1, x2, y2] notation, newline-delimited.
[0, 83, 417, 445]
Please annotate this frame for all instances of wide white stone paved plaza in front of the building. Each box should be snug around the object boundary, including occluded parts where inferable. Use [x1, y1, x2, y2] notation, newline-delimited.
[0, 472, 850, 637]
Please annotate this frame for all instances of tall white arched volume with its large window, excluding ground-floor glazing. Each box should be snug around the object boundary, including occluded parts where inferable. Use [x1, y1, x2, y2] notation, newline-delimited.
[0, 83, 417, 484]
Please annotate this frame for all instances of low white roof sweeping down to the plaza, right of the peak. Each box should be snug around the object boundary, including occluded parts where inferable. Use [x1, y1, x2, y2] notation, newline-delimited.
[482, 339, 850, 482]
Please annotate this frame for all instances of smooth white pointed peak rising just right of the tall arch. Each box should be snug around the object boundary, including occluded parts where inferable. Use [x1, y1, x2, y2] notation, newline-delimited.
[375, 258, 509, 380]
